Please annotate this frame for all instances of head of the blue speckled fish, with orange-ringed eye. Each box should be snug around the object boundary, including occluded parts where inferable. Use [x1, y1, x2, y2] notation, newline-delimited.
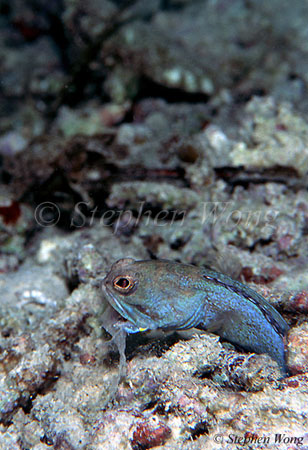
[102, 258, 202, 331]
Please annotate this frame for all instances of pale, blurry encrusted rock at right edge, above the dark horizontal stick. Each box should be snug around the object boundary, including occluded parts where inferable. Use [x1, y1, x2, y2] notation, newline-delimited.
[230, 98, 308, 177]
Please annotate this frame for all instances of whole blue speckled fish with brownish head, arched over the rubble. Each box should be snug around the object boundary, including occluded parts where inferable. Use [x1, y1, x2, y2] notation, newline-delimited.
[103, 258, 288, 373]
